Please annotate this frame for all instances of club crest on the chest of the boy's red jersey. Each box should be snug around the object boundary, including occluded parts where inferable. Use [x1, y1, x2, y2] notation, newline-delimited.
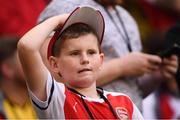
[116, 107, 129, 120]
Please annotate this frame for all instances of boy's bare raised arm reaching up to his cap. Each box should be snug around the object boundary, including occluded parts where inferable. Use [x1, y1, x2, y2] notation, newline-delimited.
[18, 14, 68, 100]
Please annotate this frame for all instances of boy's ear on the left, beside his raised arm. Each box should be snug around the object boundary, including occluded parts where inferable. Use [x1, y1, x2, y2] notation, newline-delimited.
[49, 56, 59, 73]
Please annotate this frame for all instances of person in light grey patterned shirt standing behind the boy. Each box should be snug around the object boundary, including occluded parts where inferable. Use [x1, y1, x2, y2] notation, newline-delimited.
[39, 0, 177, 109]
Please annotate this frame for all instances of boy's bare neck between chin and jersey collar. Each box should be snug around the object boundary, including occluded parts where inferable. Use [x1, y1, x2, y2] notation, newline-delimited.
[70, 83, 100, 98]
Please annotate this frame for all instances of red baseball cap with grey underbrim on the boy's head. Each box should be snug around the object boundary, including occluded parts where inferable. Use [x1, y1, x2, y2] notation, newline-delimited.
[47, 7, 105, 58]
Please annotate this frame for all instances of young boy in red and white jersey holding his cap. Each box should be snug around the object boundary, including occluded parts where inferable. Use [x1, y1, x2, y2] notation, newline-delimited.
[18, 7, 143, 119]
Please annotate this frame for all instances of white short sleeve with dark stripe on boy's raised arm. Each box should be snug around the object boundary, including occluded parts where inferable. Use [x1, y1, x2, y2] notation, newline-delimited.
[28, 73, 65, 119]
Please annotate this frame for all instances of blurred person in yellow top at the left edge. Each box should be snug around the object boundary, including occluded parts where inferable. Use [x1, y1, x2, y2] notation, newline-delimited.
[0, 37, 36, 119]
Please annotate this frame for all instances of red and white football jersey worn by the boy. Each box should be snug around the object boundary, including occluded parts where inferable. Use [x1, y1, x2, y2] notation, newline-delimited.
[29, 71, 143, 120]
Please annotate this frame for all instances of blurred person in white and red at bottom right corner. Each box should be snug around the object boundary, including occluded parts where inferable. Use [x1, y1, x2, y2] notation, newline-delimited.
[143, 79, 180, 120]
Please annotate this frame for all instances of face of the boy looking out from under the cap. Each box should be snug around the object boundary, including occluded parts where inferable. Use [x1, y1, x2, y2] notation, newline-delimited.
[50, 34, 103, 87]
